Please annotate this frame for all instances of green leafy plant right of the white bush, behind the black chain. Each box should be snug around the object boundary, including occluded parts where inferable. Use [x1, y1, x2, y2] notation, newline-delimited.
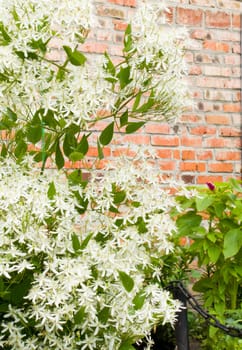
[176, 179, 242, 350]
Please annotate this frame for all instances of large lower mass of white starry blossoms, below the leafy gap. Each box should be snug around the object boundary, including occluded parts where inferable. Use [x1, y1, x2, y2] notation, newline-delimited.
[0, 155, 180, 350]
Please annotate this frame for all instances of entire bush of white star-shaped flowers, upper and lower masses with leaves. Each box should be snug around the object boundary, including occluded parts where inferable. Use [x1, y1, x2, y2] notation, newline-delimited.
[0, 0, 187, 350]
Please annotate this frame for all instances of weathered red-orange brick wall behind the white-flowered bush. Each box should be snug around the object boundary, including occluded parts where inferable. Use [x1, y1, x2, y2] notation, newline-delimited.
[83, 0, 242, 184]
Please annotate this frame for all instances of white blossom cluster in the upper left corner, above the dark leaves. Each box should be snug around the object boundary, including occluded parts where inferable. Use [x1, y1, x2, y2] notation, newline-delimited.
[0, 0, 111, 128]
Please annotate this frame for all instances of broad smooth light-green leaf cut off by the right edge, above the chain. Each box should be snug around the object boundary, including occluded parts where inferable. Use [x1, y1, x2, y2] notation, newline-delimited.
[223, 228, 242, 259]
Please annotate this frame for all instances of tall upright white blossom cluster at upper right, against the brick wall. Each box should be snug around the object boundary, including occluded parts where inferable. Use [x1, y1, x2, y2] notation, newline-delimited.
[125, 0, 191, 121]
